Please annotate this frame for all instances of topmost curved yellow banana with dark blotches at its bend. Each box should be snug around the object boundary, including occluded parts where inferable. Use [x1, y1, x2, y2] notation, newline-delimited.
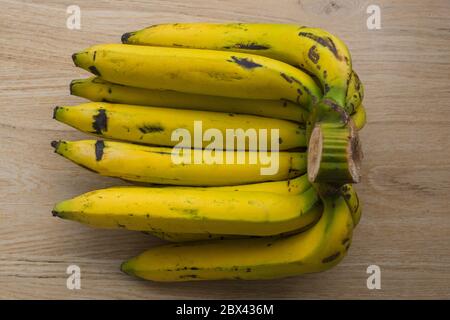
[122, 23, 362, 114]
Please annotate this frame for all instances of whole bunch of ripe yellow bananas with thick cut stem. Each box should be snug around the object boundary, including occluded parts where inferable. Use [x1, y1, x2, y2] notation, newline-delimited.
[52, 23, 366, 281]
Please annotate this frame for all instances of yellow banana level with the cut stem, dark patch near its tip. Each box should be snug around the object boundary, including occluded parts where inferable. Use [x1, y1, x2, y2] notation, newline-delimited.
[52, 140, 306, 188]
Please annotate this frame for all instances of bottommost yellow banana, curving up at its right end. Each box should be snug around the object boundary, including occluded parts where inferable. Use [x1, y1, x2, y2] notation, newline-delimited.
[121, 191, 353, 281]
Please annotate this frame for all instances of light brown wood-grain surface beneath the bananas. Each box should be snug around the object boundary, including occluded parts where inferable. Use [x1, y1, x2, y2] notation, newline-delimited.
[0, 0, 450, 299]
